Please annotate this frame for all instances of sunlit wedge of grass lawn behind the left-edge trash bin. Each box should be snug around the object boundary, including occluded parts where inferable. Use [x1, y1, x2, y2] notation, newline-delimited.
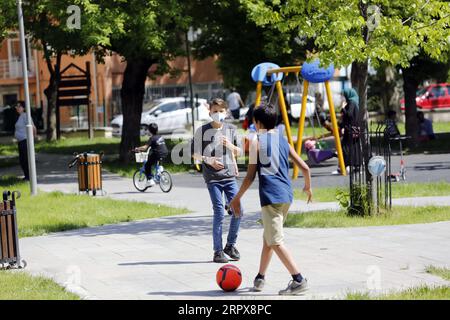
[0, 177, 188, 237]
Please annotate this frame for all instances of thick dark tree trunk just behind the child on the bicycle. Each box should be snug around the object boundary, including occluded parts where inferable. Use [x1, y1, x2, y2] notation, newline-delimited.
[119, 58, 156, 163]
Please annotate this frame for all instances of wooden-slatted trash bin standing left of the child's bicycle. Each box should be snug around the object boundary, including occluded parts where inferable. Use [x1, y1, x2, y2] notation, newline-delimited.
[69, 152, 103, 196]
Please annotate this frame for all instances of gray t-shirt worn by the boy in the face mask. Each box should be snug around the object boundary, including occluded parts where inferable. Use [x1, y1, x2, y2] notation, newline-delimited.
[193, 123, 237, 183]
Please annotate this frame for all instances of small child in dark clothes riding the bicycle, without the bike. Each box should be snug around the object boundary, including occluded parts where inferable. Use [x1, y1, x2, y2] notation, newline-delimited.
[135, 123, 169, 187]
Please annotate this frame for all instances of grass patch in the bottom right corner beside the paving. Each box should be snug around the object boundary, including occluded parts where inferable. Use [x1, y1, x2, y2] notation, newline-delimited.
[346, 266, 450, 300]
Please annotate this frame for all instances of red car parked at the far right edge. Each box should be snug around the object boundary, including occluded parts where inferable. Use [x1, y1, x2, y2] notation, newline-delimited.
[400, 83, 450, 110]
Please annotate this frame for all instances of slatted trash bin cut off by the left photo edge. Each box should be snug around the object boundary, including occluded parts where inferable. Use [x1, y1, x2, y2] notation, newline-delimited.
[0, 191, 26, 269]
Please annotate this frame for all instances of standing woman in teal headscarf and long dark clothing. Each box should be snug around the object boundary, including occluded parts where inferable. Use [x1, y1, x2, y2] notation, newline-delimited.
[338, 88, 361, 173]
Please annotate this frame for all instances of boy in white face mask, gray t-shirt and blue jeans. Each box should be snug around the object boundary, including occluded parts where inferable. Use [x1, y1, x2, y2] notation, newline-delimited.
[193, 98, 241, 263]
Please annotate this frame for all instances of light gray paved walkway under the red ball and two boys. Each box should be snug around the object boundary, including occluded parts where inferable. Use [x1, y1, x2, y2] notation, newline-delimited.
[3, 155, 450, 300]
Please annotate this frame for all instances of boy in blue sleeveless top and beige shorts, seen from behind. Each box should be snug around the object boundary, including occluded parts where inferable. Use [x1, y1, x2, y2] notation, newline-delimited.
[230, 105, 312, 295]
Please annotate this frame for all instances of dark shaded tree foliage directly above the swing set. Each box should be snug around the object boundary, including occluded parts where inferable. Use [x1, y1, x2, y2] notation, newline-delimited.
[190, 0, 307, 96]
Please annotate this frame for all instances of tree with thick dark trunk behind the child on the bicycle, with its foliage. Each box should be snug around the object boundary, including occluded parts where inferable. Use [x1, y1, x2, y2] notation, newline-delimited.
[93, 0, 190, 162]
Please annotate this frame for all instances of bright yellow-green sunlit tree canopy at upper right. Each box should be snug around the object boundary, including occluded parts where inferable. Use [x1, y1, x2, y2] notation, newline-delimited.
[241, 0, 450, 139]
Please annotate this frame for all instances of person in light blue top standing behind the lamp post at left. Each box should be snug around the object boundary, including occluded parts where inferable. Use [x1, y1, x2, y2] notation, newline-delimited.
[14, 101, 36, 181]
